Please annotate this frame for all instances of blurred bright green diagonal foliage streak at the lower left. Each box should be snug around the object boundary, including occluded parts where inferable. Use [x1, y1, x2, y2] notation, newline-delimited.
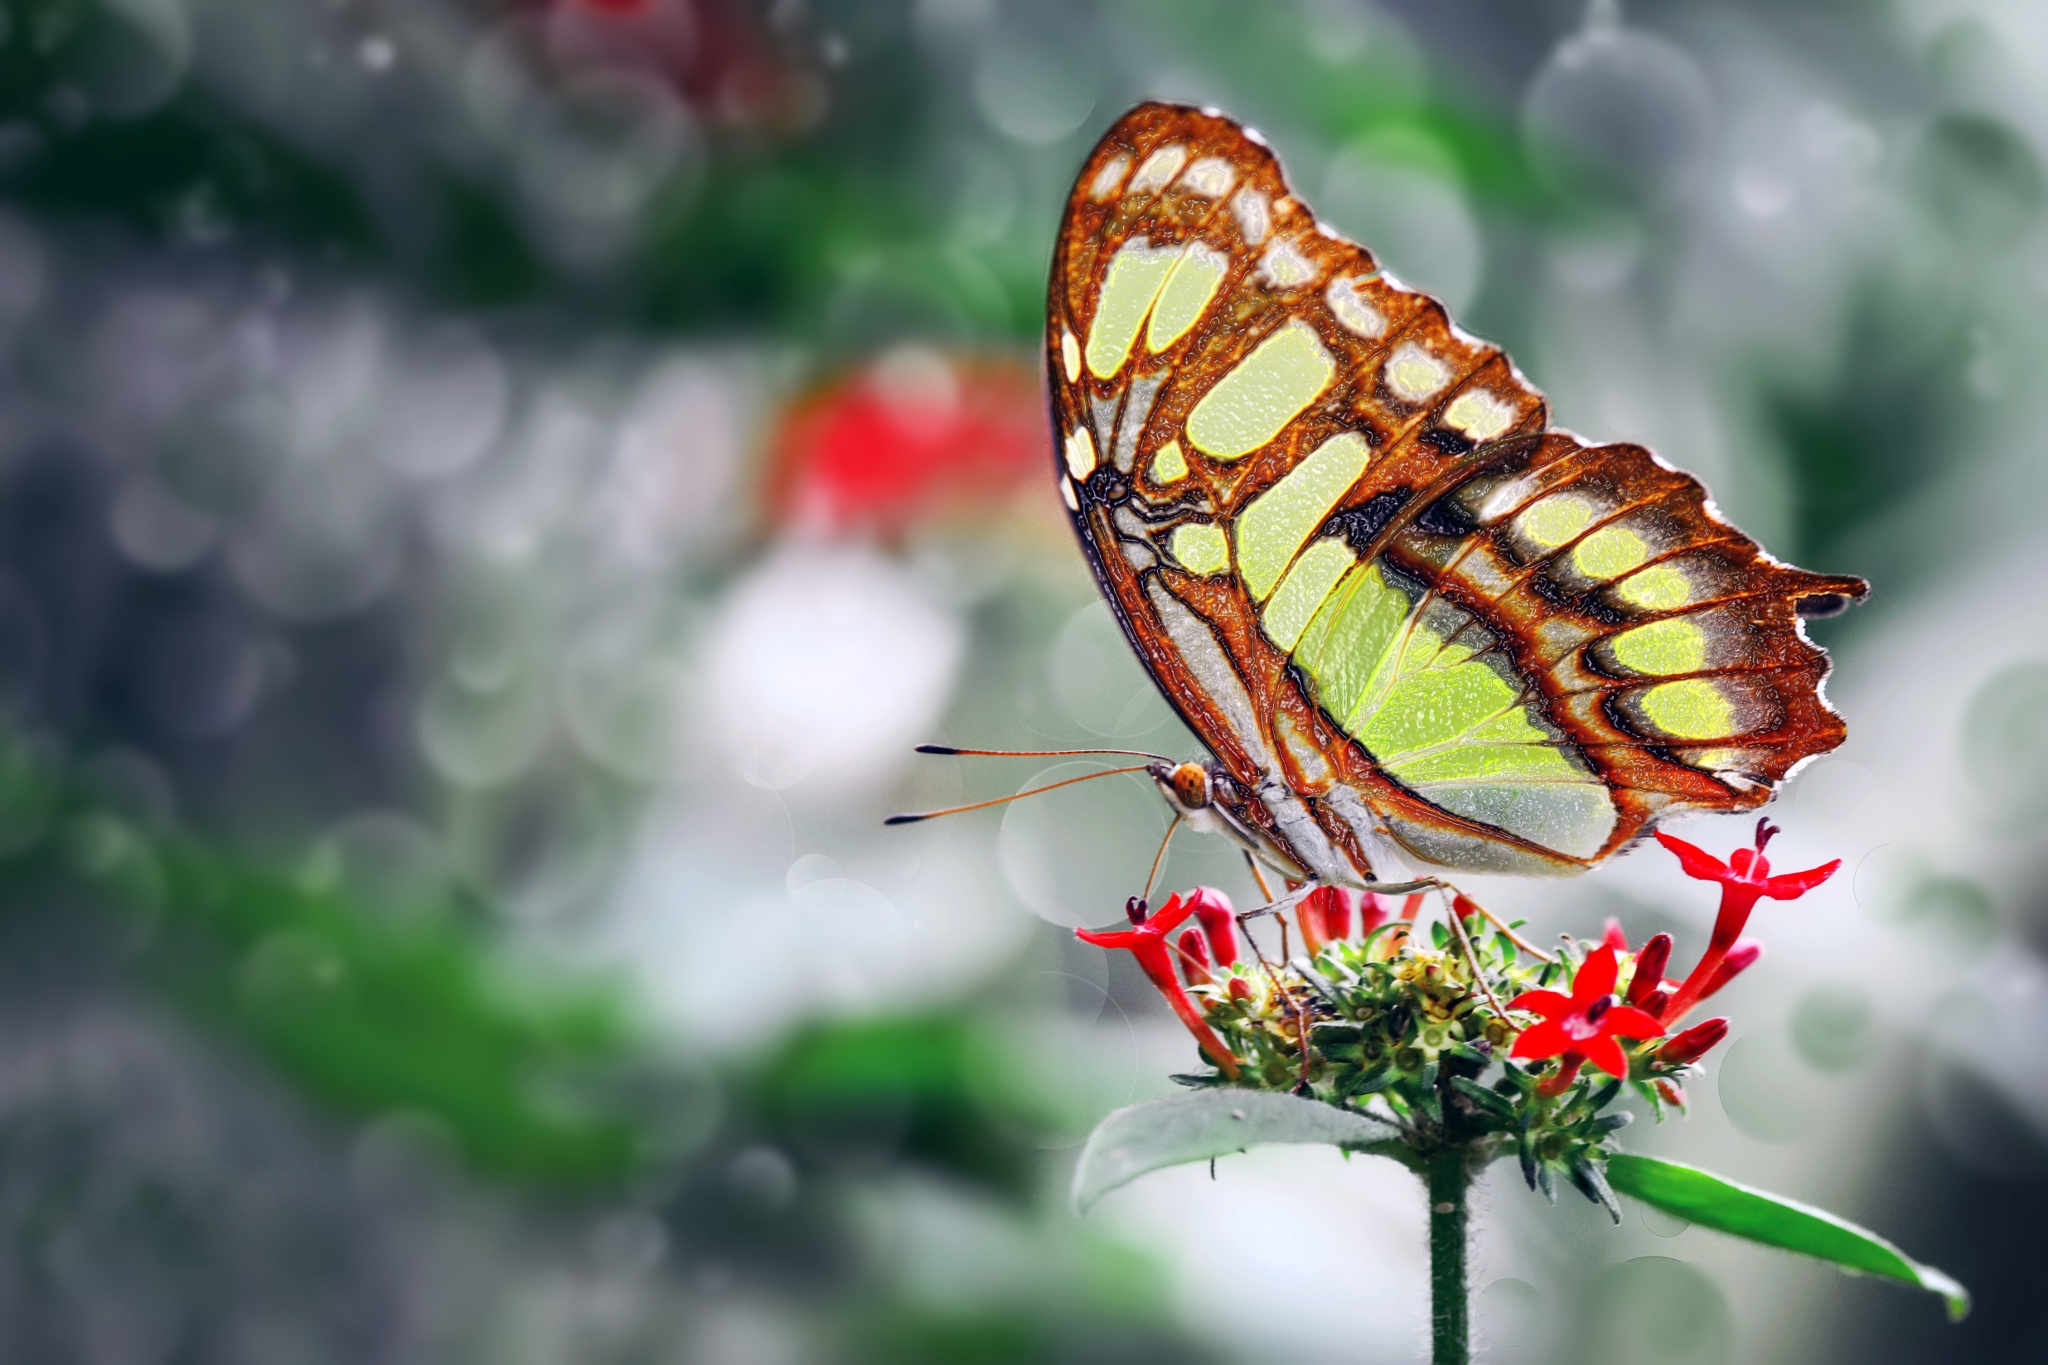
[0, 743, 639, 1185]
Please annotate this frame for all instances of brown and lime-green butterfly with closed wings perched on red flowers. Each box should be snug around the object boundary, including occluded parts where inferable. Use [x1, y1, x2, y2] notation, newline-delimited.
[1044, 104, 1868, 886]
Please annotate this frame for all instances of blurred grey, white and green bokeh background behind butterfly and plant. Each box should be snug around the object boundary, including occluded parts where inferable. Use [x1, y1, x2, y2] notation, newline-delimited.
[0, 0, 2048, 1365]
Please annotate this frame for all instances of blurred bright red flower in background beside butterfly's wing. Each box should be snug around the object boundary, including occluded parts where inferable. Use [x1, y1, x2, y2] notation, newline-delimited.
[768, 346, 1051, 532]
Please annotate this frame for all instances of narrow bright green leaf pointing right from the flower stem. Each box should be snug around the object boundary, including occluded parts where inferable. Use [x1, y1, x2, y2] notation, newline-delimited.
[1608, 1152, 1970, 1322]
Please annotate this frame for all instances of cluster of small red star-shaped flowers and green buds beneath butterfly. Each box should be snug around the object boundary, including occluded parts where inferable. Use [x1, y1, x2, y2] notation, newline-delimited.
[1077, 821, 1839, 1212]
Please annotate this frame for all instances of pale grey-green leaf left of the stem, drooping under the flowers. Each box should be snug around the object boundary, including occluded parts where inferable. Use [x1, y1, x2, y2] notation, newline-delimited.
[1073, 1091, 1399, 1214]
